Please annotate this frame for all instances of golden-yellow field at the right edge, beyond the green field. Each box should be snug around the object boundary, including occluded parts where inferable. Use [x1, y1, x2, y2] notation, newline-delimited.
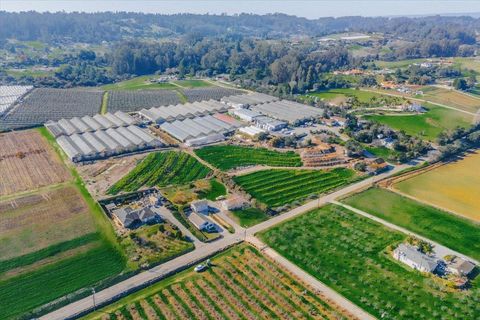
[393, 151, 480, 221]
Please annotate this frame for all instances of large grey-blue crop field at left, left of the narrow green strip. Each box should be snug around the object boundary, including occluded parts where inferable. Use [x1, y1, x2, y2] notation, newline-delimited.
[0, 88, 103, 130]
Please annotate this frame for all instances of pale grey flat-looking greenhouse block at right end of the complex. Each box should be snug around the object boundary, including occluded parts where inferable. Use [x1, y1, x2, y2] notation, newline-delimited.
[251, 100, 323, 124]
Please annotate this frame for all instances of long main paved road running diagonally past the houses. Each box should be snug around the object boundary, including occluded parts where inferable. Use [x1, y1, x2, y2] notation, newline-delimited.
[40, 165, 408, 320]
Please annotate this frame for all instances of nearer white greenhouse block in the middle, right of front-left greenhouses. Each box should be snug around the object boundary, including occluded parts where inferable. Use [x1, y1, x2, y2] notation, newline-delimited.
[160, 115, 241, 145]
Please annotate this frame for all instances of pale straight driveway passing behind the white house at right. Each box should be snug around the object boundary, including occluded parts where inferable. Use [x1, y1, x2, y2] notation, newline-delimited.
[330, 200, 479, 265]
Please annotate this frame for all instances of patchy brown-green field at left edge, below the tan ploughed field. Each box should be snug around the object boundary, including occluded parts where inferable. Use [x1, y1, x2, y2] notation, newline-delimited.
[0, 186, 96, 260]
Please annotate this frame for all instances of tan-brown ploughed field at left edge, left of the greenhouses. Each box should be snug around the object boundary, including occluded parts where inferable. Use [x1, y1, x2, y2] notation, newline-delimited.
[0, 130, 71, 197]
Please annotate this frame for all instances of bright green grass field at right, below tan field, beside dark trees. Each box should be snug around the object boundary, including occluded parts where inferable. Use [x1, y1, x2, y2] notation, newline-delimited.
[364, 103, 473, 141]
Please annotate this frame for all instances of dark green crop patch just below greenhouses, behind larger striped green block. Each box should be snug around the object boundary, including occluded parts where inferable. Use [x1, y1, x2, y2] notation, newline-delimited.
[195, 145, 302, 170]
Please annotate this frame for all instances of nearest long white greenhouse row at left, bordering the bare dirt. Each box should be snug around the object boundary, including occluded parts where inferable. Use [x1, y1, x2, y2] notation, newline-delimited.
[57, 125, 164, 162]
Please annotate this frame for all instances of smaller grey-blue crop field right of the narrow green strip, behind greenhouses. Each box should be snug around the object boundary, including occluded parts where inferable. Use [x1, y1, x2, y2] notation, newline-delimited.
[107, 90, 181, 112]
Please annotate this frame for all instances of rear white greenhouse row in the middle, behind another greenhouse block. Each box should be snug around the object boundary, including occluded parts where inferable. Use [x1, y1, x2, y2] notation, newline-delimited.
[138, 100, 228, 124]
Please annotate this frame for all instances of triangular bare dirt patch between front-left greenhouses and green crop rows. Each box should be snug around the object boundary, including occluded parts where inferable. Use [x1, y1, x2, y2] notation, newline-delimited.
[77, 154, 146, 199]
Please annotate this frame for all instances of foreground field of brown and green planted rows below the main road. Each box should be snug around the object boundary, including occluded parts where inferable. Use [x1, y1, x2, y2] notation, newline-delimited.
[92, 246, 348, 319]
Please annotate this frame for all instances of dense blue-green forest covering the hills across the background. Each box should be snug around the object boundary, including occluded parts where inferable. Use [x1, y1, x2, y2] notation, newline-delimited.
[0, 12, 480, 94]
